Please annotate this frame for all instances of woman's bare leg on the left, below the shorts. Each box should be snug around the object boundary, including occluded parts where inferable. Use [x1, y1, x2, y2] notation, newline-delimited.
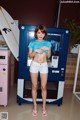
[30, 73, 38, 111]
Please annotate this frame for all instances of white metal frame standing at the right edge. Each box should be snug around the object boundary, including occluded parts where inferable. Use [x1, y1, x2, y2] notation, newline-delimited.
[73, 48, 80, 100]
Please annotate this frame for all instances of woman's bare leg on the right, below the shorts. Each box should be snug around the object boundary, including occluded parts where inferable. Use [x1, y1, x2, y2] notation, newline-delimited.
[40, 73, 48, 111]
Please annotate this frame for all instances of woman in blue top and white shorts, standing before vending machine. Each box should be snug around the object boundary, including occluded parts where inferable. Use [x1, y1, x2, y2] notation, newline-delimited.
[28, 25, 51, 116]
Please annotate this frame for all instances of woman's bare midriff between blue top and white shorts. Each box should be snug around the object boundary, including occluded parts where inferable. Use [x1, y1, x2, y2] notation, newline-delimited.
[33, 53, 47, 63]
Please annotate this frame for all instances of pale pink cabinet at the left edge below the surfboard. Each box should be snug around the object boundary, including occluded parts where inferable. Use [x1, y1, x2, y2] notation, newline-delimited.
[0, 50, 10, 106]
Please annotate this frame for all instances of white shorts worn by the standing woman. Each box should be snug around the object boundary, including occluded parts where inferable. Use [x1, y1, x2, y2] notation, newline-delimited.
[30, 61, 48, 73]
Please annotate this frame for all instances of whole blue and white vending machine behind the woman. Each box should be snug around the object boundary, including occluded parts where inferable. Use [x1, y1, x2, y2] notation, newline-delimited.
[17, 25, 69, 105]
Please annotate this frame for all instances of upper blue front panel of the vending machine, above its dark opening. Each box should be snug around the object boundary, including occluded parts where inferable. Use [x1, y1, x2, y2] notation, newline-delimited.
[18, 25, 69, 81]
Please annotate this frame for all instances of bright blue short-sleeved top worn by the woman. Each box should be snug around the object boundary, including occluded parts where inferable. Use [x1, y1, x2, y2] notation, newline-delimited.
[28, 40, 51, 53]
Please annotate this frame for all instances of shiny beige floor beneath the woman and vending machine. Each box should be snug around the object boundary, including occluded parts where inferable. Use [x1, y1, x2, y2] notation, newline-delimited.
[0, 87, 80, 120]
